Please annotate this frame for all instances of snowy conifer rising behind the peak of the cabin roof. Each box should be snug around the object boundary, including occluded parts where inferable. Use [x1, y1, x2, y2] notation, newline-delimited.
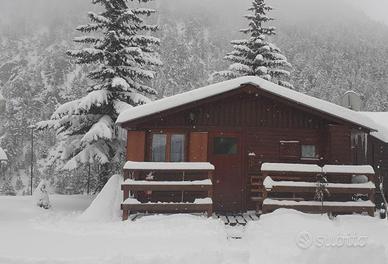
[214, 0, 293, 88]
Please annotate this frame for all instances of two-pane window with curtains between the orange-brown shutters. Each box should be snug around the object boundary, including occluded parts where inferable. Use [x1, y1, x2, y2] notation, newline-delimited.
[151, 134, 185, 162]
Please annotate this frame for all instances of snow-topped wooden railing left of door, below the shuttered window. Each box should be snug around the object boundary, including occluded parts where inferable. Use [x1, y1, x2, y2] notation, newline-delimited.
[121, 161, 214, 220]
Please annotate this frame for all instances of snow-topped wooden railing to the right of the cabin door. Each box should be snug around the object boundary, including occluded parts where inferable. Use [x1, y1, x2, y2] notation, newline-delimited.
[261, 163, 376, 215]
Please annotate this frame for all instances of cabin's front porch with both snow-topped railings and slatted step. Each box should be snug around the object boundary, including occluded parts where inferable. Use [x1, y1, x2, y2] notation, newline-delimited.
[121, 161, 375, 221]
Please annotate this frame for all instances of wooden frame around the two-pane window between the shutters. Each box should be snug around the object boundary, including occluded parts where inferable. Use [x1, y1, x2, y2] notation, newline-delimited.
[147, 130, 189, 162]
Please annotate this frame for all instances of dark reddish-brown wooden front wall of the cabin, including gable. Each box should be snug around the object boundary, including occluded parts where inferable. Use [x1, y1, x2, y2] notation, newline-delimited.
[124, 87, 364, 209]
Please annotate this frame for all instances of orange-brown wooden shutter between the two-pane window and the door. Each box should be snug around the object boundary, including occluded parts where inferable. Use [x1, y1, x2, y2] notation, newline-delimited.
[189, 132, 208, 162]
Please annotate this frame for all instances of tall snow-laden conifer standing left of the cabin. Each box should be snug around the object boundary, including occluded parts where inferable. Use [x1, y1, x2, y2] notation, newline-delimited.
[38, 0, 161, 188]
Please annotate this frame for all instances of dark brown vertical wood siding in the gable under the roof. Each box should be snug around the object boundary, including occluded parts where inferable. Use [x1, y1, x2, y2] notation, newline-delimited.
[132, 93, 327, 129]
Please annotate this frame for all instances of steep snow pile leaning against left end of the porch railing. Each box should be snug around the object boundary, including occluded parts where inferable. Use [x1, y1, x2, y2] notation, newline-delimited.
[79, 174, 123, 222]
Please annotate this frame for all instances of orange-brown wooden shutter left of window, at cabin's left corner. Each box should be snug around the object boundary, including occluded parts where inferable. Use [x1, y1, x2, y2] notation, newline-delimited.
[127, 131, 145, 161]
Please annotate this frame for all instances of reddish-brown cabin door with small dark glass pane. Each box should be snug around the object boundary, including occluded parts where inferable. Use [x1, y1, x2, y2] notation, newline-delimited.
[208, 132, 243, 212]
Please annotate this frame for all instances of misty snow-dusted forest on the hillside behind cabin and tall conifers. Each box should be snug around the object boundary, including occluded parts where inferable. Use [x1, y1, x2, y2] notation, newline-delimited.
[0, 0, 388, 194]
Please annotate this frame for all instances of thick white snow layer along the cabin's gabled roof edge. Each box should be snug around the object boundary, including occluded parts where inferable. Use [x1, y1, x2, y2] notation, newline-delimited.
[116, 76, 375, 130]
